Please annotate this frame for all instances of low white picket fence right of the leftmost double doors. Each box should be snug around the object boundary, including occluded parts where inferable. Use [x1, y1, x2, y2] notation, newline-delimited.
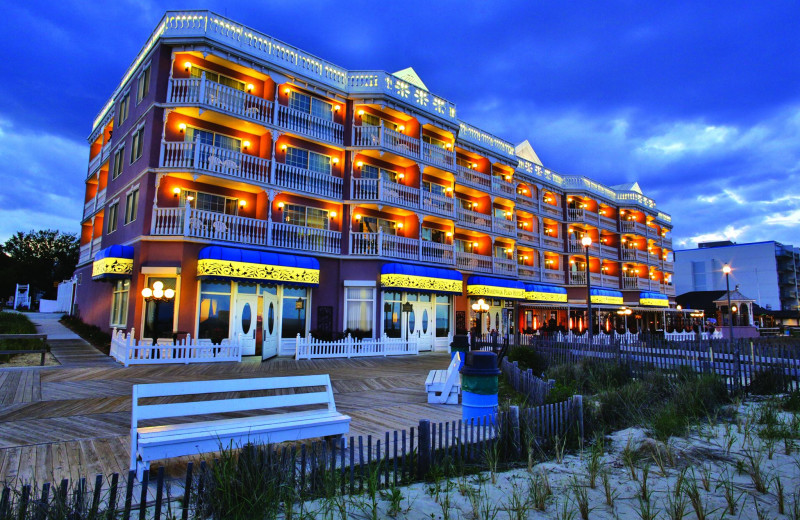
[295, 334, 419, 359]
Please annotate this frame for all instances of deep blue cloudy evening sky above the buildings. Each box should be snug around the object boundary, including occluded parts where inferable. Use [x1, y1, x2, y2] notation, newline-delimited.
[0, 0, 800, 248]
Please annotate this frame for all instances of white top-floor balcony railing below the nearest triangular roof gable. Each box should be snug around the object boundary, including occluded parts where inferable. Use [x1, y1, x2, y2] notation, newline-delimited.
[353, 126, 456, 170]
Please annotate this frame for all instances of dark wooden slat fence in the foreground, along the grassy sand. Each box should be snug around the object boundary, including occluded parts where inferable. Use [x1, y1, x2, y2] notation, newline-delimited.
[0, 395, 583, 520]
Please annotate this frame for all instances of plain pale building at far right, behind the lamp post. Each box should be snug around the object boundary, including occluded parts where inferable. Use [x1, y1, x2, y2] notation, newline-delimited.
[675, 241, 800, 311]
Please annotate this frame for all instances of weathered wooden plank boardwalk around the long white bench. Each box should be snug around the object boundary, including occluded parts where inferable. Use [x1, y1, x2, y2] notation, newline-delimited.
[0, 350, 461, 483]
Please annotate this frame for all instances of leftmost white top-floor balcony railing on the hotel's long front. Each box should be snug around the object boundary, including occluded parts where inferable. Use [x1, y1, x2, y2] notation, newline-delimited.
[167, 77, 276, 128]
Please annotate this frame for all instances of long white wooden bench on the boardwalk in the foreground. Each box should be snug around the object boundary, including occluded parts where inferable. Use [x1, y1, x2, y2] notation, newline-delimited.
[131, 374, 350, 479]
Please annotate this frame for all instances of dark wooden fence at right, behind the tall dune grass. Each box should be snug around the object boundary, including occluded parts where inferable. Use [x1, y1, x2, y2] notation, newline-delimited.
[515, 336, 800, 391]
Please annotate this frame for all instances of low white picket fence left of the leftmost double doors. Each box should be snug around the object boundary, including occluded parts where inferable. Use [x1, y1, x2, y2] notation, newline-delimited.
[110, 329, 242, 366]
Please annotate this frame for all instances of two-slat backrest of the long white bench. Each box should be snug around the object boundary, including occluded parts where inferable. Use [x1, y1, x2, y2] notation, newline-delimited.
[131, 374, 336, 428]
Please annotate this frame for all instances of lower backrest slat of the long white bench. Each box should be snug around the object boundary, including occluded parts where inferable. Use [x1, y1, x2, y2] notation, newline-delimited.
[136, 388, 329, 422]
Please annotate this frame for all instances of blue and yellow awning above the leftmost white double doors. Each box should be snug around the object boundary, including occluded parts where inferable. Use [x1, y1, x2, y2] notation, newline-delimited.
[197, 246, 319, 286]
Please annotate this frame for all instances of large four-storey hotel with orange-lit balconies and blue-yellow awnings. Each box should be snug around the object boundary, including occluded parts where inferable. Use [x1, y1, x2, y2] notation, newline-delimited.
[77, 11, 675, 357]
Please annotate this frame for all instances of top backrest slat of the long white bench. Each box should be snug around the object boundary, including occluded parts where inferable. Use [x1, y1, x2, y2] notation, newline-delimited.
[133, 374, 331, 398]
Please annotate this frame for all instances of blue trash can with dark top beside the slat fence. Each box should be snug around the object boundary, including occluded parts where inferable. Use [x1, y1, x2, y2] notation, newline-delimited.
[461, 351, 500, 424]
